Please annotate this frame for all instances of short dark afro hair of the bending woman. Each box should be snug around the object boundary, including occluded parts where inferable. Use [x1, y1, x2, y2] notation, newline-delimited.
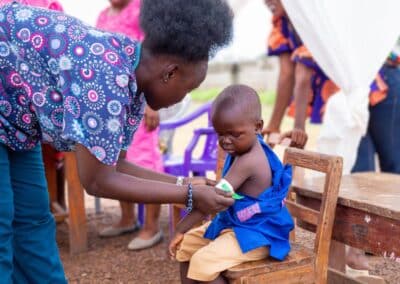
[140, 0, 233, 61]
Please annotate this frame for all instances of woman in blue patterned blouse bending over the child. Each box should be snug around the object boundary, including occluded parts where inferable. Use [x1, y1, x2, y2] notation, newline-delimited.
[0, 0, 233, 283]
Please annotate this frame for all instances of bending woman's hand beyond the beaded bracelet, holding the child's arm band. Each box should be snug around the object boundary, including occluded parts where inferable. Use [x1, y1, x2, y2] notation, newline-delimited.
[193, 185, 235, 215]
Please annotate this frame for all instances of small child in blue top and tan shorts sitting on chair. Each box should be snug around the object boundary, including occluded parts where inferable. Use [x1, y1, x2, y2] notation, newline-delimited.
[169, 85, 293, 283]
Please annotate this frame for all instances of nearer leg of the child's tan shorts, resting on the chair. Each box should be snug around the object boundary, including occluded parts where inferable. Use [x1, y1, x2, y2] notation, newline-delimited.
[188, 230, 268, 283]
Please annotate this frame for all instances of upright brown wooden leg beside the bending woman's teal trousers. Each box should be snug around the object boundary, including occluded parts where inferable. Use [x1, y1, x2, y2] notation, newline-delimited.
[65, 153, 87, 254]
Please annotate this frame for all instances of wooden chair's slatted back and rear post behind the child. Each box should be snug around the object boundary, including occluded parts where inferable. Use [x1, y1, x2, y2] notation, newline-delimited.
[283, 148, 343, 283]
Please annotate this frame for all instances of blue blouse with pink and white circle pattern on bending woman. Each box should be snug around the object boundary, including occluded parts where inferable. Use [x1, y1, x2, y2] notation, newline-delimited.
[0, 3, 145, 165]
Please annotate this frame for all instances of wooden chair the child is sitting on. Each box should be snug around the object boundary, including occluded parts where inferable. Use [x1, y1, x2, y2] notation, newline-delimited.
[224, 148, 342, 284]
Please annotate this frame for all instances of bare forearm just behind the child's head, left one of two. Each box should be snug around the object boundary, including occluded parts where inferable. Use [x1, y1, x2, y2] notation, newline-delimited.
[263, 53, 295, 134]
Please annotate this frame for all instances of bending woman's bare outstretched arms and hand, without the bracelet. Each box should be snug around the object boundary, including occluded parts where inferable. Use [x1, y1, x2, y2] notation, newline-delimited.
[76, 144, 233, 213]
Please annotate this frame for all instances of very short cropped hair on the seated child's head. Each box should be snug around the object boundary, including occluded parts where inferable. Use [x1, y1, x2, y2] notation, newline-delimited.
[211, 84, 261, 120]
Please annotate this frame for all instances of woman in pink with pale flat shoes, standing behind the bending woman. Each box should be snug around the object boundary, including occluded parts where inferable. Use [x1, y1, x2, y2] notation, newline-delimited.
[96, 0, 163, 250]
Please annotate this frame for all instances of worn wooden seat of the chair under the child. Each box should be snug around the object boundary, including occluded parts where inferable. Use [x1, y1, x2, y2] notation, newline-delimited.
[224, 243, 315, 283]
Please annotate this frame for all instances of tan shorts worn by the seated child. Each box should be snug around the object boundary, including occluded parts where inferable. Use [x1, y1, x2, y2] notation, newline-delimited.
[176, 222, 268, 281]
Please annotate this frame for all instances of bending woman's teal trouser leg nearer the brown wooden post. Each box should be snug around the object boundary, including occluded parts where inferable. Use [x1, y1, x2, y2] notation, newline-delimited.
[8, 146, 66, 283]
